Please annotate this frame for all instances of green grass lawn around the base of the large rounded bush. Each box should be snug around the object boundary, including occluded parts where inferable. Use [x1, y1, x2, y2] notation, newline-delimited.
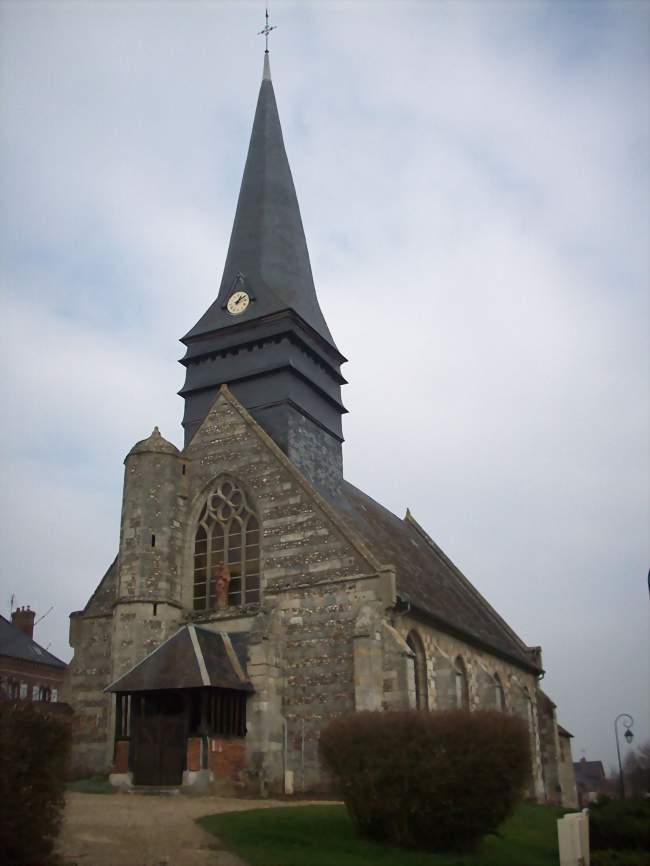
[198, 804, 564, 866]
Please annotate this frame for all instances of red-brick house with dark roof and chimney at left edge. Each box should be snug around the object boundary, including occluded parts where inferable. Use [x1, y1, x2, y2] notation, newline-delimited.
[0, 607, 67, 703]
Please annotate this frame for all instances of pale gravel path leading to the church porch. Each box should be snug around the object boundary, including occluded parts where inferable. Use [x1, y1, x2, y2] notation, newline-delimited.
[59, 792, 305, 866]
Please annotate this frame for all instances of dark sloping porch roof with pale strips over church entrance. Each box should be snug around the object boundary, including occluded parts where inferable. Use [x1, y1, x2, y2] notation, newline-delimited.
[104, 625, 254, 692]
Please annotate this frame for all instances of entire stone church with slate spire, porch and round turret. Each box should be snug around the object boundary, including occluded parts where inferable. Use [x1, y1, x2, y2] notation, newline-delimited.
[66, 53, 567, 801]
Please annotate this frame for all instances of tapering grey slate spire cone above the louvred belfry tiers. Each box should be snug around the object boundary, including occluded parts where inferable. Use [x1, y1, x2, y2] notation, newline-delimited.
[183, 52, 335, 347]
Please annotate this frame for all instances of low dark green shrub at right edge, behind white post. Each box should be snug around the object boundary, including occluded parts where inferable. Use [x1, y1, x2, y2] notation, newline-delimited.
[589, 797, 650, 851]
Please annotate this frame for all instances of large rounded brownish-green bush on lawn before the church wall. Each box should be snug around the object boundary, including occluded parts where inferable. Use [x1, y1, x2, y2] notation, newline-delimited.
[320, 710, 530, 850]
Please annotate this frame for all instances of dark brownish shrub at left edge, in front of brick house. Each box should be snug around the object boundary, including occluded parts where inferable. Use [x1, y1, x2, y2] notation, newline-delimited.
[0, 701, 70, 866]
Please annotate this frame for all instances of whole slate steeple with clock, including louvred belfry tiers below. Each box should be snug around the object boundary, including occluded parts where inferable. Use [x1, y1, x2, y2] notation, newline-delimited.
[180, 38, 346, 486]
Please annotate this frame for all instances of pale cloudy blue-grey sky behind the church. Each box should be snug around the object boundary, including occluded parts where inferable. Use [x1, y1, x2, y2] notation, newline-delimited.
[0, 0, 650, 763]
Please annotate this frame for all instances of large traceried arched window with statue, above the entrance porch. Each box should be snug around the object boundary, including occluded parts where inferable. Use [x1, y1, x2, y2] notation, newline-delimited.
[194, 477, 260, 610]
